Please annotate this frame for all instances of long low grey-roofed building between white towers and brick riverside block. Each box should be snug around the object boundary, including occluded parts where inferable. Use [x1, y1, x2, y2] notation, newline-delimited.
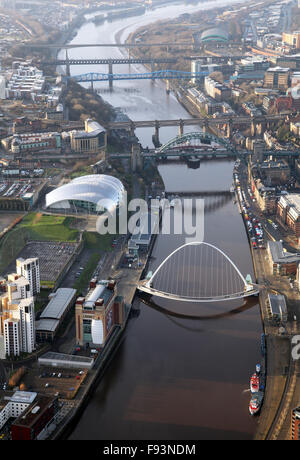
[35, 288, 76, 342]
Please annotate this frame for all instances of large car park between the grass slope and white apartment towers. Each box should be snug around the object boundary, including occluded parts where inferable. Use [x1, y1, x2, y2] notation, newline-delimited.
[8, 241, 78, 283]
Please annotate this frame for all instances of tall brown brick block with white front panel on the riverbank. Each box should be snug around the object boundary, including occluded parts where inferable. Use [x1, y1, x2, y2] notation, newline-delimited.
[75, 280, 124, 347]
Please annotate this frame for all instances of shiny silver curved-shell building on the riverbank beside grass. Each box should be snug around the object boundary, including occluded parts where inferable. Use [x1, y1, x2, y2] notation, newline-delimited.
[46, 174, 125, 212]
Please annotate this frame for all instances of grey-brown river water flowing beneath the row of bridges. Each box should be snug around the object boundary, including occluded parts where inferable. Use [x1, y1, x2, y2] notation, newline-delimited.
[65, 1, 262, 440]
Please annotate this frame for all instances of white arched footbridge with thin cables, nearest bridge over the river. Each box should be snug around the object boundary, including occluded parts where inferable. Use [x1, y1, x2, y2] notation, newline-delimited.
[137, 242, 259, 303]
